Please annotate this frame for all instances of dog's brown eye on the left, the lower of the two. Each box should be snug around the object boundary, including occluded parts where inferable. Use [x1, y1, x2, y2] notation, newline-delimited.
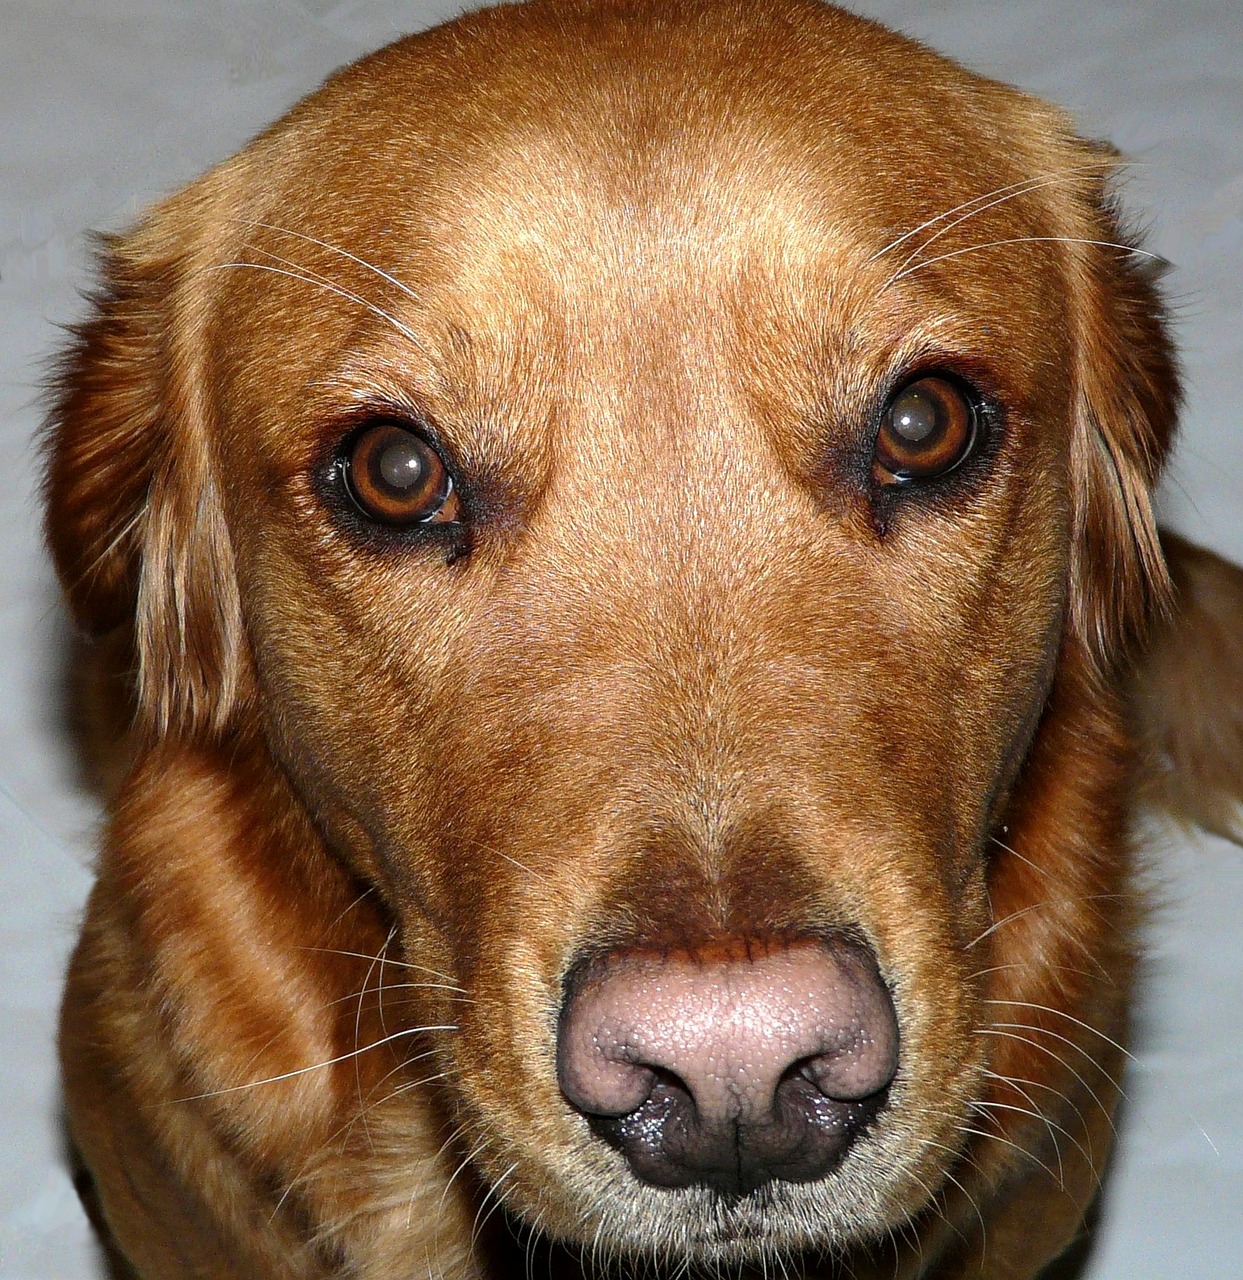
[344, 422, 462, 525]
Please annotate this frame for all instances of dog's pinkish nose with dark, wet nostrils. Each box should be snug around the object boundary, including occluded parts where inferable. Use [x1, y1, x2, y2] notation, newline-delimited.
[557, 940, 899, 1196]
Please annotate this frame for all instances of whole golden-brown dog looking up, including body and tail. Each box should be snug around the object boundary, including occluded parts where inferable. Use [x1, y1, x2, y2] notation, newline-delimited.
[46, 0, 1243, 1280]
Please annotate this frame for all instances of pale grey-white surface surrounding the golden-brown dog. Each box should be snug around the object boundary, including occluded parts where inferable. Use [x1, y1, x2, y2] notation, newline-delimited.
[0, 0, 1243, 1280]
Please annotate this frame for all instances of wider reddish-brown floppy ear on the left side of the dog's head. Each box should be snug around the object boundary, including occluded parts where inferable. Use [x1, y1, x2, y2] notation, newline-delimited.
[45, 188, 243, 736]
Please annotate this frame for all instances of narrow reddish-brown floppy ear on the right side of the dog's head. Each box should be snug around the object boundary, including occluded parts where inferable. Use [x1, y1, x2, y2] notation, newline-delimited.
[1064, 147, 1179, 669]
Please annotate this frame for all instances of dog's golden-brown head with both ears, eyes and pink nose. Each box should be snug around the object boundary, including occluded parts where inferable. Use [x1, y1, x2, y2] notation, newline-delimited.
[49, 3, 1174, 1262]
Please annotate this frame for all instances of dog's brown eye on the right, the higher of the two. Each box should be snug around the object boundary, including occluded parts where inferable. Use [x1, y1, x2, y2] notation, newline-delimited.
[872, 378, 978, 485]
